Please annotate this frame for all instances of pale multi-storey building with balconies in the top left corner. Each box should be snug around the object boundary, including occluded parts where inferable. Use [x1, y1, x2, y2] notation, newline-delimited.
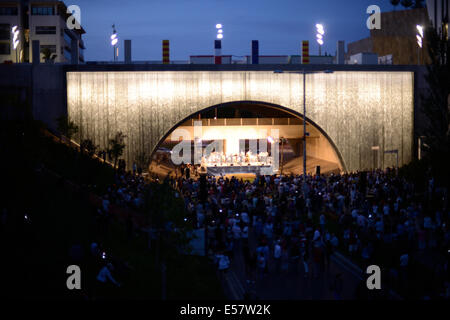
[0, 0, 85, 63]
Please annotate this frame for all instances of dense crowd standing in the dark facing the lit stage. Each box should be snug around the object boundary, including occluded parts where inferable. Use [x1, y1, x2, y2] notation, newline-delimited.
[174, 169, 450, 298]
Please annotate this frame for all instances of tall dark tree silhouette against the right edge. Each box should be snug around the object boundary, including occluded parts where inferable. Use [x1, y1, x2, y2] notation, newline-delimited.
[421, 25, 450, 188]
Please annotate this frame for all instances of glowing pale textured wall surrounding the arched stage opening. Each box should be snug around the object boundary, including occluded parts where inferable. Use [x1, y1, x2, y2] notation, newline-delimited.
[67, 71, 413, 171]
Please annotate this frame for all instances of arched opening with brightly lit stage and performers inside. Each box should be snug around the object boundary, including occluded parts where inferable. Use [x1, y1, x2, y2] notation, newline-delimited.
[148, 101, 344, 178]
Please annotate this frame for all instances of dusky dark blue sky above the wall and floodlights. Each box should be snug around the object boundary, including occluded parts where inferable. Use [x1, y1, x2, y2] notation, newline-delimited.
[70, 0, 394, 60]
